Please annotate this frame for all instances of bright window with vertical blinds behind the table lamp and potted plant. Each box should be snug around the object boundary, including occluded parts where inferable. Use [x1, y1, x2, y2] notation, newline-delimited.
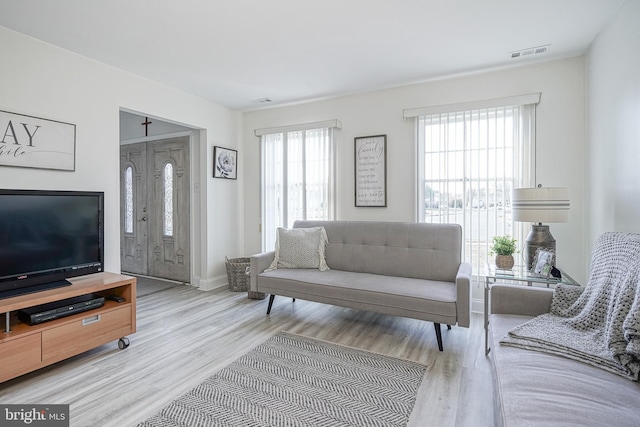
[405, 95, 539, 272]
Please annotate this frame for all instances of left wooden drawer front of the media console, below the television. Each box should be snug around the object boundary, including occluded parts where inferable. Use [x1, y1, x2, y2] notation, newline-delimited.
[0, 334, 42, 382]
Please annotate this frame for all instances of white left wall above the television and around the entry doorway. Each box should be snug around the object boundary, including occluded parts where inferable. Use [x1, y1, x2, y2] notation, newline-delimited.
[0, 27, 242, 288]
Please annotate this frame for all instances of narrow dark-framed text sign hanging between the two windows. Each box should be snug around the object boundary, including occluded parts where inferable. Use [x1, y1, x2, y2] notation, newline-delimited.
[354, 135, 387, 207]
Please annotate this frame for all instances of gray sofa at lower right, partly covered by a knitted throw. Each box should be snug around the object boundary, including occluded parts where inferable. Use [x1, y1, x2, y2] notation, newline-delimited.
[489, 284, 640, 427]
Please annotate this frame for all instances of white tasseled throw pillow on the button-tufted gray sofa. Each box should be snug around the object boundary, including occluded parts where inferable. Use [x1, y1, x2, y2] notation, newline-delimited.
[269, 227, 329, 271]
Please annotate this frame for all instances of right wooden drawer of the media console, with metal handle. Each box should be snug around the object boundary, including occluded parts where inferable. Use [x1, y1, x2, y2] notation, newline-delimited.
[42, 305, 133, 363]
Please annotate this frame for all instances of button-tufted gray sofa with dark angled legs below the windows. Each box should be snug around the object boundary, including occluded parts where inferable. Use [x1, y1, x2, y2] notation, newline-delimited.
[251, 221, 471, 351]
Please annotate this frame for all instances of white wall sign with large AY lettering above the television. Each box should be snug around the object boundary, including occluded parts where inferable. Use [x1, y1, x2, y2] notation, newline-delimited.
[0, 111, 76, 171]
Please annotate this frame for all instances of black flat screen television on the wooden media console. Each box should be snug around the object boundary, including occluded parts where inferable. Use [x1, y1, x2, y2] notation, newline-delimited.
[0, 189, 104, 298]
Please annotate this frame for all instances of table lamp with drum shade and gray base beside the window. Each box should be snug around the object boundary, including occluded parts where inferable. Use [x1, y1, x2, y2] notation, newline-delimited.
[511, 185, 570, 269]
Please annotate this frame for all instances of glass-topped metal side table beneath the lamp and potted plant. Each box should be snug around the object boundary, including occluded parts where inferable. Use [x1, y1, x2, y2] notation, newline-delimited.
[482, 264, 580, 356]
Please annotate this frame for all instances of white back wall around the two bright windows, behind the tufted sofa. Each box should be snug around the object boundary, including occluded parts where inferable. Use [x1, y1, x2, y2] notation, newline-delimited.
[243, 57, 585, 308]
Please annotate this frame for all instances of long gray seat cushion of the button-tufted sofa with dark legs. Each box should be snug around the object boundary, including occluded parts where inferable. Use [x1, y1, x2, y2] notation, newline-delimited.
[258, 269, 457, 324]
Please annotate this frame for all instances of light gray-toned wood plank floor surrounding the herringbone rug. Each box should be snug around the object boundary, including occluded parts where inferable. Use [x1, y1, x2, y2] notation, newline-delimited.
[0, 286, 493, 427]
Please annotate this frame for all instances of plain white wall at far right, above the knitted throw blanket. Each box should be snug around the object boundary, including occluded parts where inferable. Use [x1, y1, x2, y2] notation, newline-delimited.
[585, 0, 640, 251]
